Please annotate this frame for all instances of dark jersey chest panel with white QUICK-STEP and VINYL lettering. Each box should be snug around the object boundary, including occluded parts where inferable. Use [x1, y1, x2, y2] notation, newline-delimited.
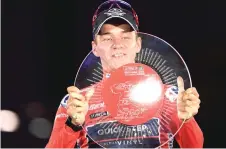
[86, 118, 160, 148]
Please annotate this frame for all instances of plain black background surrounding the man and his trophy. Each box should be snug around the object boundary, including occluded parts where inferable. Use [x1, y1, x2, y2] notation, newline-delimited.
[1, 0, 226, 148]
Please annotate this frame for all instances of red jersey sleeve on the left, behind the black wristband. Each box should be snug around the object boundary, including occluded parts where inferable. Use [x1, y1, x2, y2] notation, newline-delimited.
[46, 95, 81, 148]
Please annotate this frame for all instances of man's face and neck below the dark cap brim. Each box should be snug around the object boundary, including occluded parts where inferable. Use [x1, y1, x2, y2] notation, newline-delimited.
[92, 24, 141, 72]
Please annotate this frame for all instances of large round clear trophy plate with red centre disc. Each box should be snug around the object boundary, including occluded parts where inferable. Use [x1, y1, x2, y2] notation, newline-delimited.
[75, 33, 192, 148]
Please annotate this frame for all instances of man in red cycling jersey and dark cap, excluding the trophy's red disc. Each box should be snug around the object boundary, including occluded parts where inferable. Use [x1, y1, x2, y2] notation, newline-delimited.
[46, 0, 204, 148]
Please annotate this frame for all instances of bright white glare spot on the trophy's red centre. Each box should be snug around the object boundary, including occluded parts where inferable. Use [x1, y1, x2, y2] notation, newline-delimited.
[129, 76, 162, 104]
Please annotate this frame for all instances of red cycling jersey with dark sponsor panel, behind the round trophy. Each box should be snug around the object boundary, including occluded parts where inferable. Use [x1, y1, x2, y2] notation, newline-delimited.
[46, 82, 204, 148]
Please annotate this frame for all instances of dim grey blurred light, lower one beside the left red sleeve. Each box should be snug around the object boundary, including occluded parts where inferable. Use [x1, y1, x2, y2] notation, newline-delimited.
[28, 118, 52, 139]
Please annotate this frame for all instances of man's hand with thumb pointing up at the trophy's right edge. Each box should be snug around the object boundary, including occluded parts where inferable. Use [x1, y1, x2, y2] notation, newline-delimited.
[177, 77, 200, 120]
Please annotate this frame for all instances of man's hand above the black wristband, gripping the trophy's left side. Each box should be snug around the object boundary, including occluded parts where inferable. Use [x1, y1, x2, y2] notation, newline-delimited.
[67, 86, 94, 125]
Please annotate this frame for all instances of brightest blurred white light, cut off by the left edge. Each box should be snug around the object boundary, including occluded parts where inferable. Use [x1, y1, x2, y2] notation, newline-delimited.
[0, 110, 20, 132]
